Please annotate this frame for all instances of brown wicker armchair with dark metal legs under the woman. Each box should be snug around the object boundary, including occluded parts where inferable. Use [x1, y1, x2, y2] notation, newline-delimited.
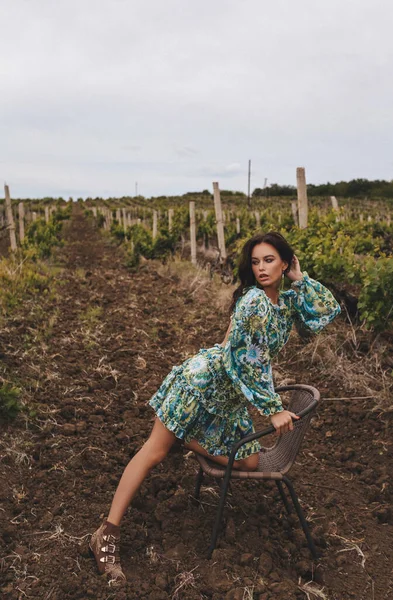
[194, 384, 320, 559]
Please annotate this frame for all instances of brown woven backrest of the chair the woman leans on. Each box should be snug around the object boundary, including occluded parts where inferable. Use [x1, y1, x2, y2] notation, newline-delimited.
[258, 385, 320, 474]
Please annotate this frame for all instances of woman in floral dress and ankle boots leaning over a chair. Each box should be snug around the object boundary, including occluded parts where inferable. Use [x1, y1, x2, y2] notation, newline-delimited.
[90, 232, 340, 581]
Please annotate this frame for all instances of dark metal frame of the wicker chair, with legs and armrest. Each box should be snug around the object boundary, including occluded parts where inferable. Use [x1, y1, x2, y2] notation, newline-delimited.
[194, 384, 320, 560]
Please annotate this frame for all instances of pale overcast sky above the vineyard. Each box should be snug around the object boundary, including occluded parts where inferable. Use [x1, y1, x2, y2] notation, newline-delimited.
[0, 0, 393, 198]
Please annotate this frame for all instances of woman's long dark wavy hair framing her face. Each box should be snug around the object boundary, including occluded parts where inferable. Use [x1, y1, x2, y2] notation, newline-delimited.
[230, 231, 294, 313]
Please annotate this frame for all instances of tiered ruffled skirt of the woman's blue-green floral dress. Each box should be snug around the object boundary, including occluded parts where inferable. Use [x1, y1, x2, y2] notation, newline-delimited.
[149, 344, 260, 460]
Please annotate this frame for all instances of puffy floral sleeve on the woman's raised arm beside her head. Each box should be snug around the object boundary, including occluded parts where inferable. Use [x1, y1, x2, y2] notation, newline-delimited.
[291, 272, 341, 333]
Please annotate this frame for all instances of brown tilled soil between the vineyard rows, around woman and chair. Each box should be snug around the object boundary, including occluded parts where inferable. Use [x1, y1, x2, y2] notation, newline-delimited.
[0, 207, 393, 600]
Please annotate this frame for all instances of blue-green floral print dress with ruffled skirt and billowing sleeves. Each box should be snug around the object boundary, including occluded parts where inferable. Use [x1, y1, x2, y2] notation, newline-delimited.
[149, 272, 340, 459]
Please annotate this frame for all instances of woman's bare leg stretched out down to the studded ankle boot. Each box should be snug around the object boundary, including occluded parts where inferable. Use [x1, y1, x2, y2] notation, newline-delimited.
[108, 417, 176, 525]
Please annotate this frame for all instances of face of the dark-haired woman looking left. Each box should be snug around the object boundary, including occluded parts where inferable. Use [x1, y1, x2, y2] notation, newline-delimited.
[251, 242, 288, 287]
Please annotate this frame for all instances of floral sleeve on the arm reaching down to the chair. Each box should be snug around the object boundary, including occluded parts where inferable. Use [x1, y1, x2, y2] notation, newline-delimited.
[220, 289, 283, 416]
